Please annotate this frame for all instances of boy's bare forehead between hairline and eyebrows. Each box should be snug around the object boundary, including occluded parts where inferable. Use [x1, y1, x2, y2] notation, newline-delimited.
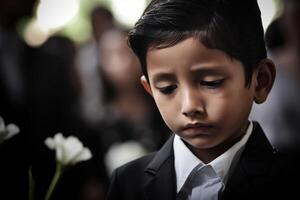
[146, 37, 242, 76]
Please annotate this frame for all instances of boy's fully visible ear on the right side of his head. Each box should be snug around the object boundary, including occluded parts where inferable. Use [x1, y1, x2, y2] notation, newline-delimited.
[254, 58, 276, 104]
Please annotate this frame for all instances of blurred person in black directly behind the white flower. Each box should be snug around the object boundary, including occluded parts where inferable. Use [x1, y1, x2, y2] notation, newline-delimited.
[29, 35, 106, 200]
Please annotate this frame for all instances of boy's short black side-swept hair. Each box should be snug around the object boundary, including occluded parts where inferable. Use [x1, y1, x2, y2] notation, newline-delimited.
[128, 0, 267, 86]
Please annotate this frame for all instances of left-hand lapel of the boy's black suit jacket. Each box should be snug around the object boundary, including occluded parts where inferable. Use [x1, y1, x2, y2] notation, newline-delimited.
[144, 135, 176, 200]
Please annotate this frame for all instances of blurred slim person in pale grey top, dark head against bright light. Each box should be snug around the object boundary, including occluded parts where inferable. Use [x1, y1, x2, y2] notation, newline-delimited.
[76, 5, 115, 197]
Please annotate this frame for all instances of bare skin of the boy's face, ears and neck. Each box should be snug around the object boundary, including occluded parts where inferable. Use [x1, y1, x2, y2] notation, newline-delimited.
[141, 37, 275, 163]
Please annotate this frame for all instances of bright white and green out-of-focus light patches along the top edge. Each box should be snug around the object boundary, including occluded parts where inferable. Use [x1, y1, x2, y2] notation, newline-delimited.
[8, 0, 282, 46]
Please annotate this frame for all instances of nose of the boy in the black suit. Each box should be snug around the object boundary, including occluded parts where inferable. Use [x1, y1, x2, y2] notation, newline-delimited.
[181, 89, 206, 117]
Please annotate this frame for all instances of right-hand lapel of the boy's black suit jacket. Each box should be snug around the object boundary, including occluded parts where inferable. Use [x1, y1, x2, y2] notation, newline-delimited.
[223, 122, 277, 199]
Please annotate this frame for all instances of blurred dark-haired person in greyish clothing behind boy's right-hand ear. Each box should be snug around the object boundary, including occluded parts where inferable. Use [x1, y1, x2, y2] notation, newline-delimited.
[251, 17, 300, 152]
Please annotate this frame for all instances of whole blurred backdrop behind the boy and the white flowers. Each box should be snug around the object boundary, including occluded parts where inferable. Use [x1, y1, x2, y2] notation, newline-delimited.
[0, 0, 300, 200]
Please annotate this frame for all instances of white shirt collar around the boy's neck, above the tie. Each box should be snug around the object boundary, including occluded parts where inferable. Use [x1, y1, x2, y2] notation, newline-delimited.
[173, 122, 253, 192]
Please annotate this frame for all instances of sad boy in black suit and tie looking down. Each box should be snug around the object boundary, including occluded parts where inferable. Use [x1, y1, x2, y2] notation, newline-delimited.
[108, 0, 296, 200]
